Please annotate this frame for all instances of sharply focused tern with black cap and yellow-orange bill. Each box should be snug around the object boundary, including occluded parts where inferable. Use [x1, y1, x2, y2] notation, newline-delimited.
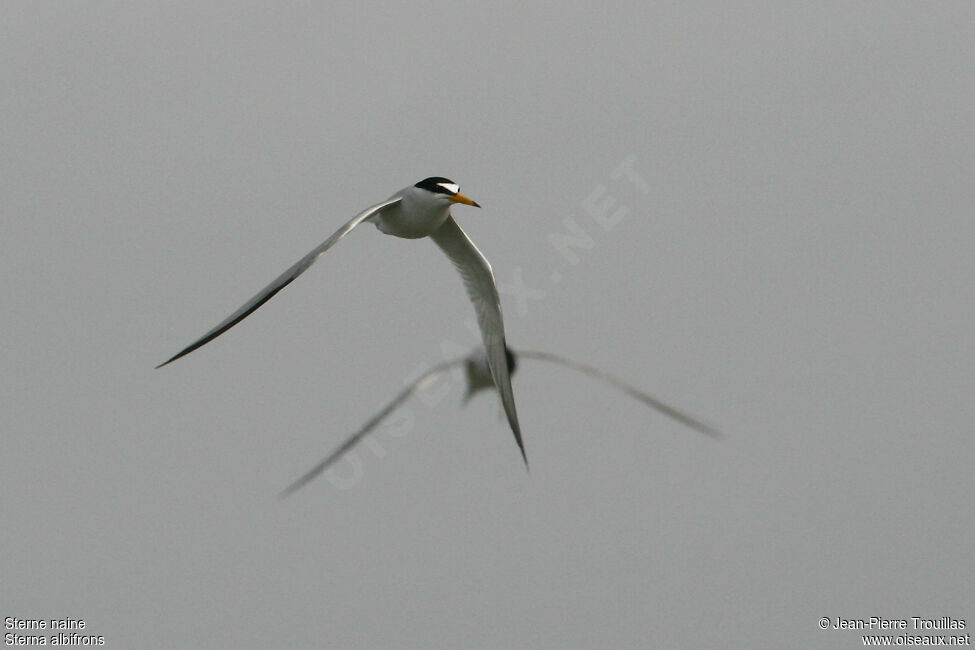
[156, 176, 528, 467]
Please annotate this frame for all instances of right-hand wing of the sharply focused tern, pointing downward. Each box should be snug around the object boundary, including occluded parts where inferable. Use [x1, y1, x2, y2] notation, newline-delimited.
[430, 217, 528, 467]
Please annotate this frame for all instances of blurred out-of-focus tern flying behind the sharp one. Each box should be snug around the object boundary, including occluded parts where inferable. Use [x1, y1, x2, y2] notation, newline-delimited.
[279, 348, 721, 498]
